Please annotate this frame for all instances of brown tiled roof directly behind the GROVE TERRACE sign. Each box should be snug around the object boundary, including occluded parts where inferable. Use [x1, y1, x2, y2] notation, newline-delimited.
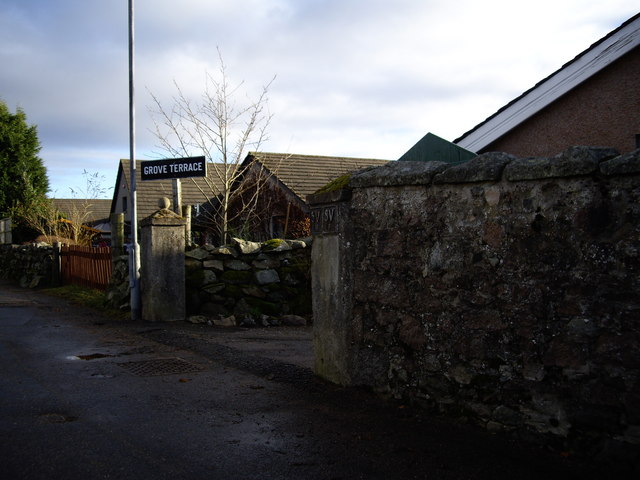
[112, 159, 221, 219]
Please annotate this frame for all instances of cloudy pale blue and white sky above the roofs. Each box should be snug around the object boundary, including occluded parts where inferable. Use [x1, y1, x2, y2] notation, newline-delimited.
[0, 0, 638, 198]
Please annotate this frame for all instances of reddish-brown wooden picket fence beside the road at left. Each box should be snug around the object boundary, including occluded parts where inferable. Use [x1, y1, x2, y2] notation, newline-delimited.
[60, 245, 112, 290]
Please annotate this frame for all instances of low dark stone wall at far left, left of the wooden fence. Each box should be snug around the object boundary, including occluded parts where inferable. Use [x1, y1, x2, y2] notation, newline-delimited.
[0, 244, 57, 288]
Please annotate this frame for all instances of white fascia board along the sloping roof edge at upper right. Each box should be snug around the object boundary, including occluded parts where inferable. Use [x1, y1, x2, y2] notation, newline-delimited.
[456, 18, 640, 152]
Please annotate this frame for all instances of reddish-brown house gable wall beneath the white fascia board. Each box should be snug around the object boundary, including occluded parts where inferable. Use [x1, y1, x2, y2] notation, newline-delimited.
[479, 48, 640, 156]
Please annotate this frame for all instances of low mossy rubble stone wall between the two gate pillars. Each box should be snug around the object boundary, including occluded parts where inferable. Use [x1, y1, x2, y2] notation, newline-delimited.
[186, 239, 311, 325]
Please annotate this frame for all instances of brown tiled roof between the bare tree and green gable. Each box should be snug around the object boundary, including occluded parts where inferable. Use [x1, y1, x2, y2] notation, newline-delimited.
[245, 152, 389, 201]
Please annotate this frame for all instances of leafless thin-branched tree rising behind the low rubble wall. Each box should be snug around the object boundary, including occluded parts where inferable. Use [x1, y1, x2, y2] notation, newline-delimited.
[151, 50, 275, 244]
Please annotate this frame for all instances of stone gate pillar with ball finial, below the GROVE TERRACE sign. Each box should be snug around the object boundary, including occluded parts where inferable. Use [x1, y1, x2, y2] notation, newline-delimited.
[140, 199, 186, 322]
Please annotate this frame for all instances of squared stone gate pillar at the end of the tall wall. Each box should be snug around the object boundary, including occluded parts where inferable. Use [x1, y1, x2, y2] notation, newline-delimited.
[307, 190, 353, 385]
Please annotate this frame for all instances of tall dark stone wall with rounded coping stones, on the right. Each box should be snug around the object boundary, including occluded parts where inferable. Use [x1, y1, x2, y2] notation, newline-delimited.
[310, 147, 640, 460]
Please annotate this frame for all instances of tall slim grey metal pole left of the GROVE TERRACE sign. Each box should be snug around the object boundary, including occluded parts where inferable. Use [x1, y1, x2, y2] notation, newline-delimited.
[129, 0, 141, 320]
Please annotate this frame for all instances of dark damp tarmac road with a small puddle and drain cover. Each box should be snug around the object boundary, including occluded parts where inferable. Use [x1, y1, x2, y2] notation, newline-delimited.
[0, 285, 615, 480]
